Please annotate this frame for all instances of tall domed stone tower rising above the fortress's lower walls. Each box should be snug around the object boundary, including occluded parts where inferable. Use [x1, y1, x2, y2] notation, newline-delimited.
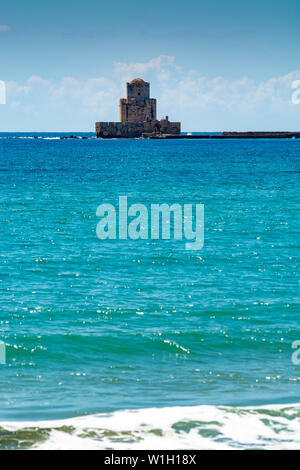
[120, 78, 156, 124]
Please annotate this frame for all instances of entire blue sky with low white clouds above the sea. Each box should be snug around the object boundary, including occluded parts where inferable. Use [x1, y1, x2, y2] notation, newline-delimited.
[0, 0, 300, 132]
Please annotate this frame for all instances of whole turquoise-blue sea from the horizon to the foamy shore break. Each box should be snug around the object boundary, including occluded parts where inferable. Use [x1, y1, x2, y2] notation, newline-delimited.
[0, 133, 300, 449]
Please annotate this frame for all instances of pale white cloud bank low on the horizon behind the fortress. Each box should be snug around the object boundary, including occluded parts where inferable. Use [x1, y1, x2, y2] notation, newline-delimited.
[0, 55, 300, 131]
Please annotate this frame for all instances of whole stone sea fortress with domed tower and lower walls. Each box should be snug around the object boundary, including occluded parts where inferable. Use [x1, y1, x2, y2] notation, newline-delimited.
[96, 78, 180, 138]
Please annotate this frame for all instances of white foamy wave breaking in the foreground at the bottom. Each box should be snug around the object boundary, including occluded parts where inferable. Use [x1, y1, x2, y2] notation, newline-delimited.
[0, 404, 300, 450]
